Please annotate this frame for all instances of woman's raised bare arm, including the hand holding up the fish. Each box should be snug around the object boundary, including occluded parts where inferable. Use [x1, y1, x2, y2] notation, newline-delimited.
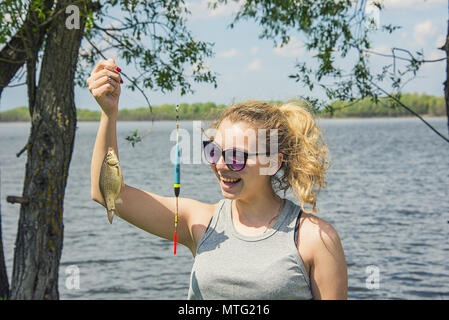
[87, 59, 214, 253]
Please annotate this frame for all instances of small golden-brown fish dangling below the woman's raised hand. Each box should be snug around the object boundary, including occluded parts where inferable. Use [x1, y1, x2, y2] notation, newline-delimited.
[100, 147, 124, 223]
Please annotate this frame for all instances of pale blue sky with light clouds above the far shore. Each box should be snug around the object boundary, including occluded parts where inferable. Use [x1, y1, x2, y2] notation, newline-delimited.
[0, 0, 448, 111]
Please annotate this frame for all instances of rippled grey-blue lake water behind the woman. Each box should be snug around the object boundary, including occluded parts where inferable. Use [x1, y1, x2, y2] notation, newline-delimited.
[0, 118, 449, 299]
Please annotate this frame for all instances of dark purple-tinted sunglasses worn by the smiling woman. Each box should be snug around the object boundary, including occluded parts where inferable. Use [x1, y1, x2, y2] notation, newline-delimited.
[203, 141, 269, 171]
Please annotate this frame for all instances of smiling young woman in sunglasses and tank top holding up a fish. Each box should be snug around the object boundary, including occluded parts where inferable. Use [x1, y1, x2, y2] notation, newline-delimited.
[87, 59, 347, 299]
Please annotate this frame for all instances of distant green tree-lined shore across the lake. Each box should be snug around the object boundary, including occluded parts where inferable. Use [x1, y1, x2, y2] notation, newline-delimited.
[0, 93, 446, 123]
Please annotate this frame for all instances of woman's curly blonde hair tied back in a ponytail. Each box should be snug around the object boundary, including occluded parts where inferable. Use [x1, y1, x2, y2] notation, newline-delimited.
[212, 100, 330, 213]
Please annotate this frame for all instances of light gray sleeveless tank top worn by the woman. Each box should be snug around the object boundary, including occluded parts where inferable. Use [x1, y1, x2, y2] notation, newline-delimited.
[188, 199, 312, 300]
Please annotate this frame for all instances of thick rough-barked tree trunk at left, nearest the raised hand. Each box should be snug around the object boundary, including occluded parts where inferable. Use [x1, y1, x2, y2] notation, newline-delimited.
[11, 0, 85, 299]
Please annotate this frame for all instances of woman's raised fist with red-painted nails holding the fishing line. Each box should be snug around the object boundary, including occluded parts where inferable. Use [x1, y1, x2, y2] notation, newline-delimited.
[87, 58, 123, 116]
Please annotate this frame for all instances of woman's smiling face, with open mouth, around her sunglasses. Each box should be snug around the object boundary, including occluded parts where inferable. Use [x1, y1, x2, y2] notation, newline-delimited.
[211, 120, 277, 200]
